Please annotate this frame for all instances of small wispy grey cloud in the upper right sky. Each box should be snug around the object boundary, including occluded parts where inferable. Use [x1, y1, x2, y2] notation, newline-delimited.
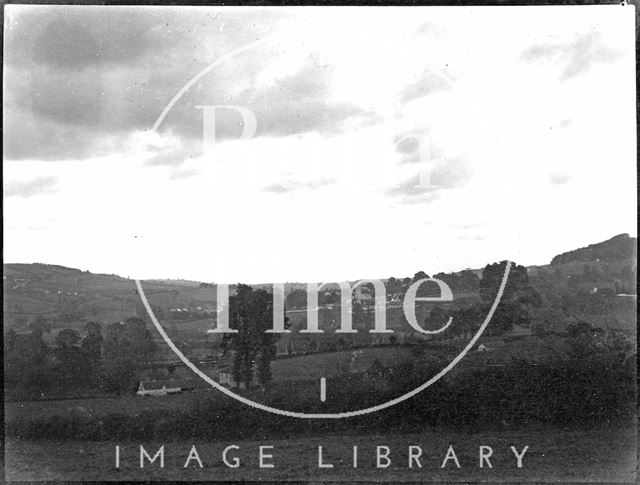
[521, 31, 620, 80]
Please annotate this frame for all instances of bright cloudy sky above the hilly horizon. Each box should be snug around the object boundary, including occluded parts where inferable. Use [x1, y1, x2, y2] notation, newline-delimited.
[3, 5, 637, 283]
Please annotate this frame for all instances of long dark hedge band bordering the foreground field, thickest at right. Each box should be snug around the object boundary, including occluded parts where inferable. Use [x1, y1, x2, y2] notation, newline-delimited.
[5, 324, 636, 441]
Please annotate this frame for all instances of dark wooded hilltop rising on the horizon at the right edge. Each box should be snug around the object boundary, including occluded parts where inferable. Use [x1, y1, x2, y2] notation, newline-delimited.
[551, 234, 638, 265]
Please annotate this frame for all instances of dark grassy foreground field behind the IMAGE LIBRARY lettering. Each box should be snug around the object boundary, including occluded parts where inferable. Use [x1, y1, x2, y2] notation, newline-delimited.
[5, 426, 637, 483]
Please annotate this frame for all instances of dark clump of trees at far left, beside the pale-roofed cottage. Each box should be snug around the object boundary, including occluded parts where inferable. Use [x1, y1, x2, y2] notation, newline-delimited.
[4, 317, 155, 399]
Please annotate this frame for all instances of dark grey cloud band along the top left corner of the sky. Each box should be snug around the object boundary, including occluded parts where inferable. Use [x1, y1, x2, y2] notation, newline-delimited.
[5, 5, 272, 71]
